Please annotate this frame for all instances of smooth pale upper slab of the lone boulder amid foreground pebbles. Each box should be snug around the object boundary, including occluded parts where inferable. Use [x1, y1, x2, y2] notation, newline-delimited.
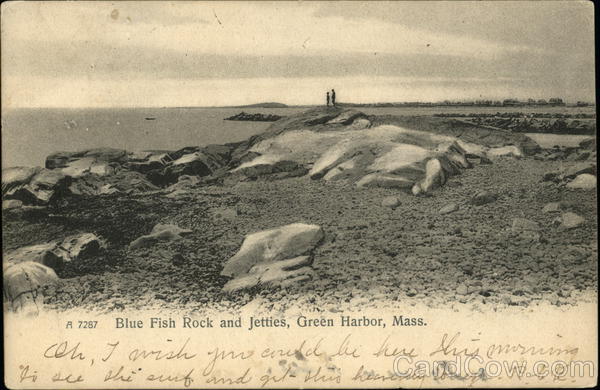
[221, 223, 323, 277]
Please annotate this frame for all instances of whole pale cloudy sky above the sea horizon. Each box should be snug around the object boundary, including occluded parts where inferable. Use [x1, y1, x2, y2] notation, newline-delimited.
[1, 1, 595, 108]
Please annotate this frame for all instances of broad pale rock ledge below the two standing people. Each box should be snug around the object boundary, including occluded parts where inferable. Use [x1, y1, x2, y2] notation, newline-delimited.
[233, 116, 480, 195]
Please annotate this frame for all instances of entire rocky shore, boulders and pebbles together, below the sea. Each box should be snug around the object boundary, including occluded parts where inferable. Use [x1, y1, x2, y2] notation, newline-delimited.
[2, 109, 597, 311]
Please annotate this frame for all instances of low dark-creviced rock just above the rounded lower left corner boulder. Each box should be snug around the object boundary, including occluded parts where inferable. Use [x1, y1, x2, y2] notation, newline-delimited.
[4, 233, 106, 269]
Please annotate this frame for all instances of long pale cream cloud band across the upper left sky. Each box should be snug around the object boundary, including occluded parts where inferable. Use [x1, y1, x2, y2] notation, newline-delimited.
[5, 2, 521, 58]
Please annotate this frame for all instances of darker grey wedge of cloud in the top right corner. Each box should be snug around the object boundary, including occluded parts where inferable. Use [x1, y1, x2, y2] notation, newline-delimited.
[314, 1, 594, 54]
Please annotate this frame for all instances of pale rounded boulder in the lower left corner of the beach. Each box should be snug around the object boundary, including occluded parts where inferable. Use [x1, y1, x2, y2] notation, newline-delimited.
[2, 261, 58, 314]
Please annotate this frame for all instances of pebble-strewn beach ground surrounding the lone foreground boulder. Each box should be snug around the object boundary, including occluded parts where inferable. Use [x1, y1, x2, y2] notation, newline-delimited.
[2, 158, 598, 312]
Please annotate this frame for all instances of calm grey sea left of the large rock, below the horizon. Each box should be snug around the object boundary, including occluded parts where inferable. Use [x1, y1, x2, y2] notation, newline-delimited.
[2, 108, 305, 168]
